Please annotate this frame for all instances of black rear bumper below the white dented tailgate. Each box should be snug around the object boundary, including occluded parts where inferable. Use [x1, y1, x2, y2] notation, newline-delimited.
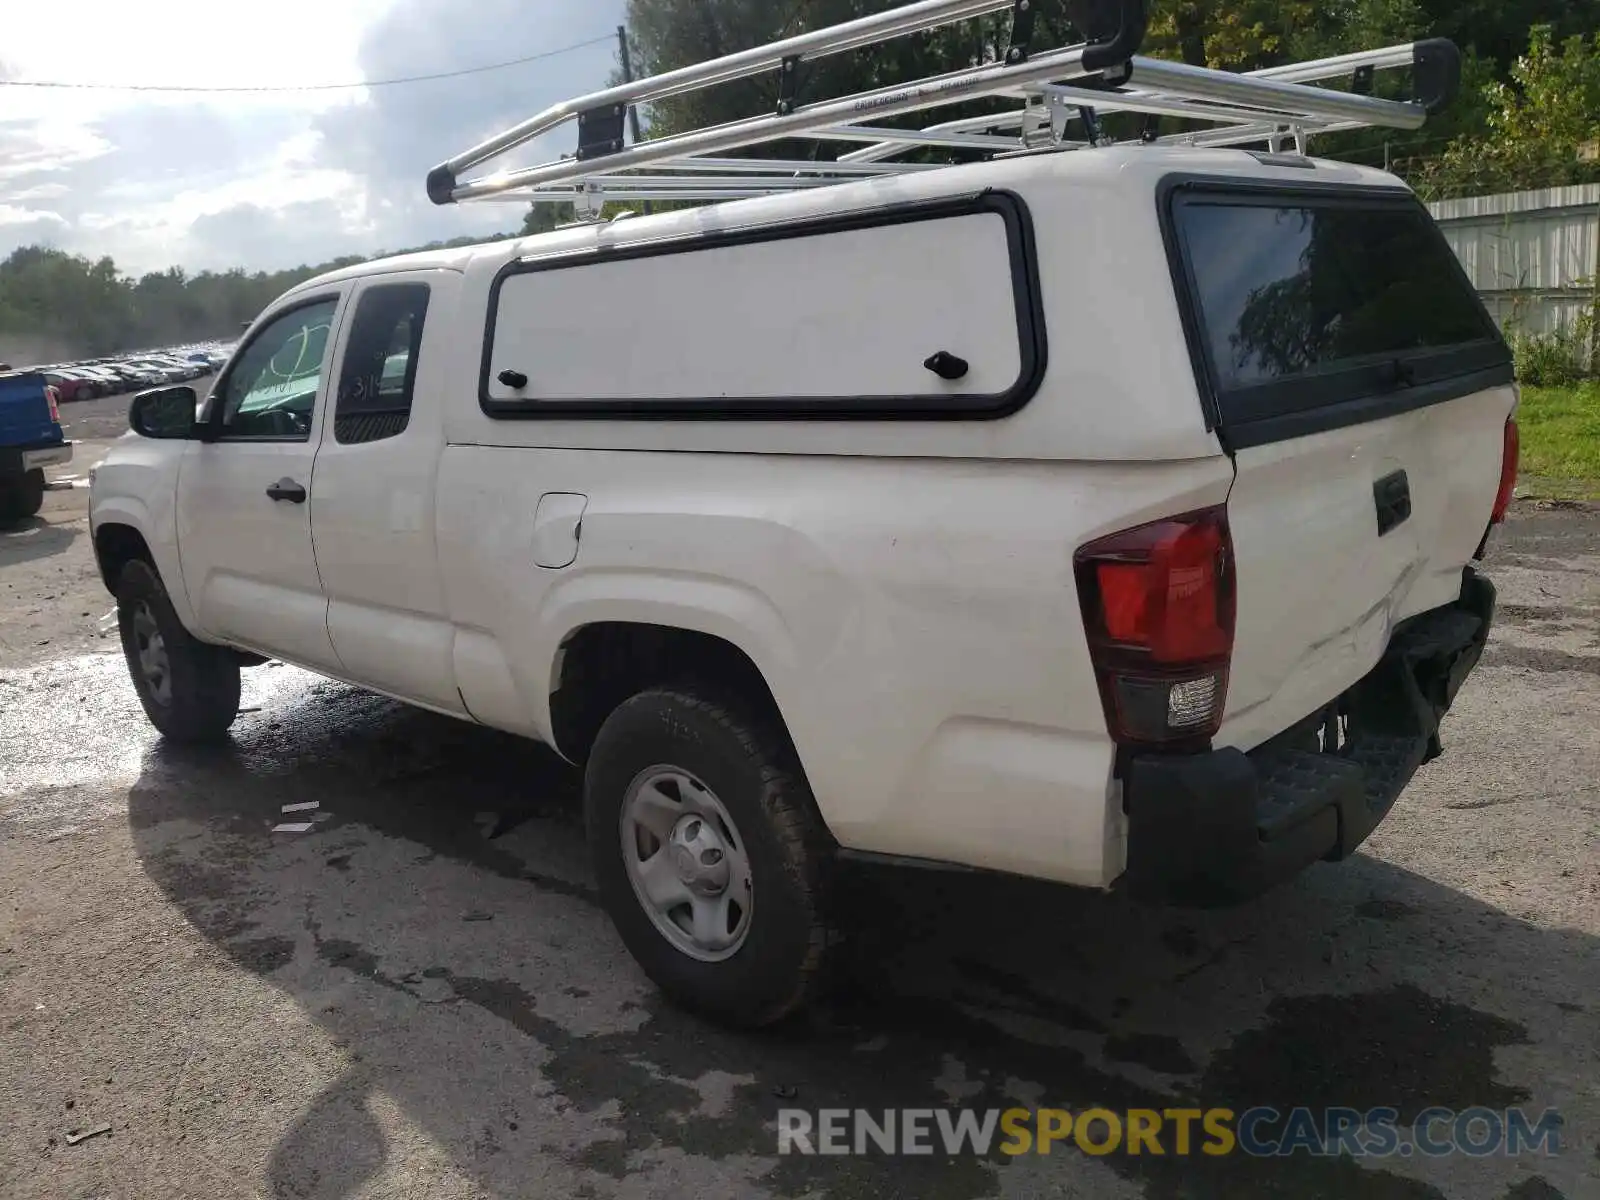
[1122, 570, 1494, 907]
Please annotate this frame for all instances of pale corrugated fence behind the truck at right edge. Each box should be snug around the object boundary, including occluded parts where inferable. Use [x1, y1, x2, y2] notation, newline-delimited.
[1429, 184, 1600, 333]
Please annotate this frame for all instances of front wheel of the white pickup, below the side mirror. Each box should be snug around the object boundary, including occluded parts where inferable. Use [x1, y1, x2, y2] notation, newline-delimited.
[117, 558, 238, 742]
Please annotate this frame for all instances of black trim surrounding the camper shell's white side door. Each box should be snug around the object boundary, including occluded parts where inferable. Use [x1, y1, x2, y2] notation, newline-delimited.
[478, 189, 1048, 421]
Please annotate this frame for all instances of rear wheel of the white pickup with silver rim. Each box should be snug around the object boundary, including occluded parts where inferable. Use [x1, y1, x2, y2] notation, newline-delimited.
[584, 688, 832, 1029]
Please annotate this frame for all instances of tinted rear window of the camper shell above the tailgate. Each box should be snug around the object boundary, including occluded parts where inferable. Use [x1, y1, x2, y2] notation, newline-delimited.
[1163, 173, 1512, 450]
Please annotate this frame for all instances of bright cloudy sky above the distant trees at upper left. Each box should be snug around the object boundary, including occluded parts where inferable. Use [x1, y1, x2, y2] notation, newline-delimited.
[0, 0, 622, 274]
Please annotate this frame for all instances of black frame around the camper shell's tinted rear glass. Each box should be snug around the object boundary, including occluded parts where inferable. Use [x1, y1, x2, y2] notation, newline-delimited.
[1157, 173, 1515, 453]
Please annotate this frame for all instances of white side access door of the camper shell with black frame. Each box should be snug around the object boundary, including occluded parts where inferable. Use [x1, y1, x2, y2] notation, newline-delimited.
[478, 190, 1046, 419]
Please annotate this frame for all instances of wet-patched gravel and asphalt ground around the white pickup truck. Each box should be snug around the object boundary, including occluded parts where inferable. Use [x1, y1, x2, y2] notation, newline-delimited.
[0, 398, 1600, 1200]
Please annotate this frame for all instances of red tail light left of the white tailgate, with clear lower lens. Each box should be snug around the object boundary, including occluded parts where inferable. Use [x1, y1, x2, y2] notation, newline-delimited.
[1074, 507, 1234, 746]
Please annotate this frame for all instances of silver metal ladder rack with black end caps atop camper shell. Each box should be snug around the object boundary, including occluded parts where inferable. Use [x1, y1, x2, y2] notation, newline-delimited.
[427, 0, 1461, 219]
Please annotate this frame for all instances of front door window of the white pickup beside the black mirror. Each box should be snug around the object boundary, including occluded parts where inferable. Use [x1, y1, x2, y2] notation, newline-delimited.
[214, 296, 339, 442]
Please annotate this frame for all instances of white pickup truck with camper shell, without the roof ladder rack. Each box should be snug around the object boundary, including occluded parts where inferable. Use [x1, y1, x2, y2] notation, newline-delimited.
[91, 11, 1517, 1024]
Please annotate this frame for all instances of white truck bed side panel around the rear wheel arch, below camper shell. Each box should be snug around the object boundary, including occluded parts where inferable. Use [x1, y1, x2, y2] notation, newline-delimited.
[438, 446, 1232, 886]
